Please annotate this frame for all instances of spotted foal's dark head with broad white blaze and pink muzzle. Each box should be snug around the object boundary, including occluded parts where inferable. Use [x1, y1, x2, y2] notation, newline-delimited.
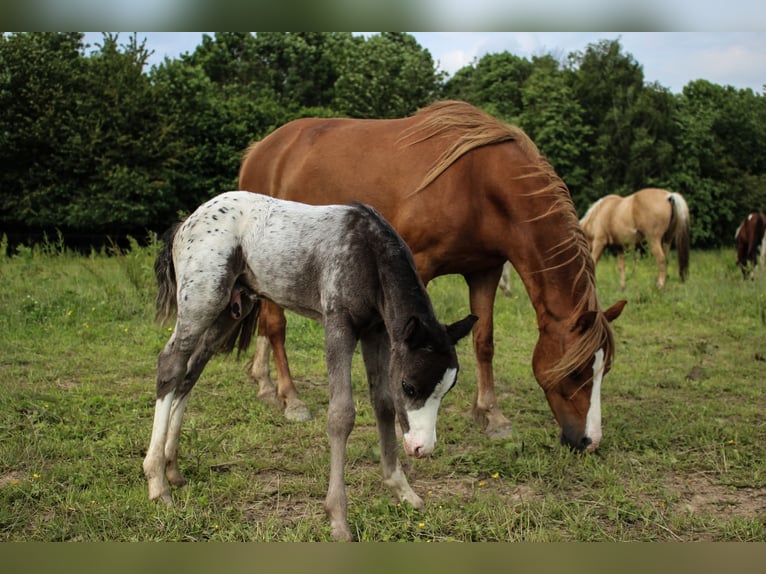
[389, 315, 478, 458]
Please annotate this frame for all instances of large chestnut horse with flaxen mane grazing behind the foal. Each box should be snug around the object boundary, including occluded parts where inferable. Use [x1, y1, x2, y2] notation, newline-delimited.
[239, 101, 624, 450]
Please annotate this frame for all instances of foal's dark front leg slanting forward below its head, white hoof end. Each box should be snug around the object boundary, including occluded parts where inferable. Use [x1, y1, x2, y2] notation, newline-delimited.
[362, 328, 424, 509]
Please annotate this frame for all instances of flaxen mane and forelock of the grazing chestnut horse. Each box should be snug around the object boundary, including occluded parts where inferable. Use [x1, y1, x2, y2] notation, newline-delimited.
[399, 100, 614, 392]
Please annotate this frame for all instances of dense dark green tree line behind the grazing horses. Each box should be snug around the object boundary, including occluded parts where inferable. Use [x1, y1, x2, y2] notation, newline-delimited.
[0, 32, 766, 248]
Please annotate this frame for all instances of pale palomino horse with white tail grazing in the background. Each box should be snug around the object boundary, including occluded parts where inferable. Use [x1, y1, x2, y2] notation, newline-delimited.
[580, 188, 691, 289]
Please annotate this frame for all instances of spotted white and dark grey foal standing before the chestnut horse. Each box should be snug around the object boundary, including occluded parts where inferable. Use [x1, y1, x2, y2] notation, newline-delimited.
[143, 191, 476, 540]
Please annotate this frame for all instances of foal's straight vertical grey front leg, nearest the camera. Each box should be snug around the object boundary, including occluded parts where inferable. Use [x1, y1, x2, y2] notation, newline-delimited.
[325, 319, 356, 540]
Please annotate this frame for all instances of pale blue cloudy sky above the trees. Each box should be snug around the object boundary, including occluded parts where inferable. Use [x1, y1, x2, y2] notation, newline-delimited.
[81, 31, 766, 93]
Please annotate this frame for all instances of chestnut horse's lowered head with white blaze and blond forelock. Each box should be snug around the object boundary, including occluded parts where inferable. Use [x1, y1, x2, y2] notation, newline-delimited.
[532, 301, 625, 452]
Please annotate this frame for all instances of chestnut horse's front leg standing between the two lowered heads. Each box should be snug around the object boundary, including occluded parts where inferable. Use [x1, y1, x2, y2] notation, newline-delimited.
[465, 265, 513, 439]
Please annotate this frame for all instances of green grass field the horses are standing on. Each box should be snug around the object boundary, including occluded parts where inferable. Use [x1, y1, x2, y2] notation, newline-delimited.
[0, 236, 766, 541]
